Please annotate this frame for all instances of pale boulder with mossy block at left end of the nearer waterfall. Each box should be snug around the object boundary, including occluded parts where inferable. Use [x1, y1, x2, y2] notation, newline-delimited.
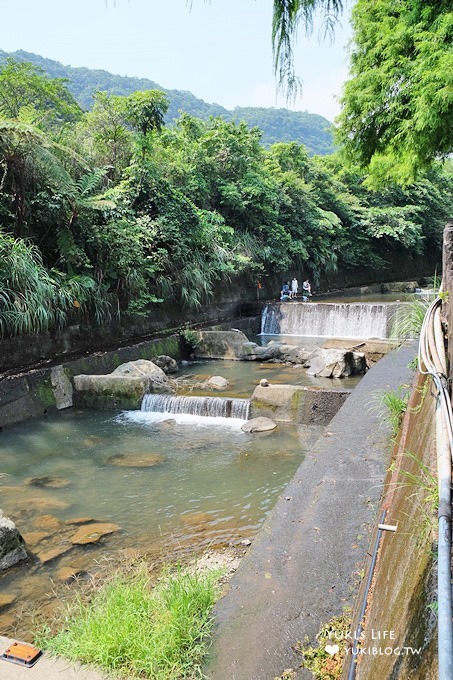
[74, 359, 173, 408]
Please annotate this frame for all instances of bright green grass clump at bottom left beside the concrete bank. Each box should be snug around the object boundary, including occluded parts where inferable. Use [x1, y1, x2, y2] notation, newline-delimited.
[37, 566, 220, 680]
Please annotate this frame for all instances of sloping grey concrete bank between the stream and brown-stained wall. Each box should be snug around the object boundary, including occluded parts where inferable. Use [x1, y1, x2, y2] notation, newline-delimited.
[205, 344, 416, 680]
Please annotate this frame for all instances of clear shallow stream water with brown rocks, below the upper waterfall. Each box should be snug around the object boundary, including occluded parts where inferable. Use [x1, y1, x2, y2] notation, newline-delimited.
[0, 361, 342, 639]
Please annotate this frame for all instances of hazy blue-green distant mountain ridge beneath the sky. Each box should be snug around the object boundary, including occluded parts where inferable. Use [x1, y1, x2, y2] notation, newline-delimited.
[0, 50, 334, 155]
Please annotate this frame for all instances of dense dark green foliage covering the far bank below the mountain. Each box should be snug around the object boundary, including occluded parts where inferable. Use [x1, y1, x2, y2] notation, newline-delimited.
[0, 62, 452, 335]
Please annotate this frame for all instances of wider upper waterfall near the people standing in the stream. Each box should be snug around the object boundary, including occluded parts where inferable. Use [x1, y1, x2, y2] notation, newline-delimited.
[261, 302, 405, 340]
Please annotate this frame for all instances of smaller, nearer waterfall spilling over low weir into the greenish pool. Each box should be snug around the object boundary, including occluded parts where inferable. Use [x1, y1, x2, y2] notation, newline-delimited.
[141, 394, 250, 420]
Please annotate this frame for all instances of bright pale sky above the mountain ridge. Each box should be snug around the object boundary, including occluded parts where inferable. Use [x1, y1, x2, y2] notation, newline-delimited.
[0, 0, 351, 120]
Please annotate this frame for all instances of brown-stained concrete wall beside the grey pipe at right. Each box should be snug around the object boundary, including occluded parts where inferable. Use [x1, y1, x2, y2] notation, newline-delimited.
[350, 375, 438, 680]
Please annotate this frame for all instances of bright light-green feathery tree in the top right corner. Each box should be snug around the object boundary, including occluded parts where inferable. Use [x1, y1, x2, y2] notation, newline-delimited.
[338, 0, 453, 185]
